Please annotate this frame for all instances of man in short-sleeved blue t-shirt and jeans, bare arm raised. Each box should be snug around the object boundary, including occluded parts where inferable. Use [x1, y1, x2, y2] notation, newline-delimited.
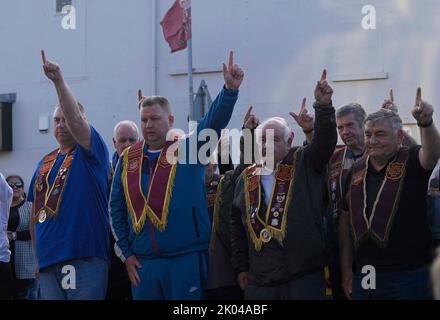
[28, 51, 110, 300]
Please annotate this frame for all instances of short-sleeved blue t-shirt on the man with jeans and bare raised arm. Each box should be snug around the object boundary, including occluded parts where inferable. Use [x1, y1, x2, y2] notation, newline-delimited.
[28, 127, 110, 270]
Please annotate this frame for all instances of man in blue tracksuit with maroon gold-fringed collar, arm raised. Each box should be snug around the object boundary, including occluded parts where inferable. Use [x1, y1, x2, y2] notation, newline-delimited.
[110, 52, 244, 300]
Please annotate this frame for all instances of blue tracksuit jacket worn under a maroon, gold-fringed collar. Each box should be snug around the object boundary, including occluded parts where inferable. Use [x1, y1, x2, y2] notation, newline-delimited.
[110, 88, 238, 261]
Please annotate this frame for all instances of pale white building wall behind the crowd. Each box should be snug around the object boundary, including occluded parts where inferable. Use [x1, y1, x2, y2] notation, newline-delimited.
[0, 0, 440, 186]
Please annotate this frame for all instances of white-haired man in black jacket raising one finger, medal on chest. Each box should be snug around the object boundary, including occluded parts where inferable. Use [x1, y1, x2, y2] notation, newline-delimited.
[231, 70, 337, 300]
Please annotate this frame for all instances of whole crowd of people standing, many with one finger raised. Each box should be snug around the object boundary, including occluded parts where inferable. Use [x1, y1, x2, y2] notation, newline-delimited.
[0, 51, 440, 300]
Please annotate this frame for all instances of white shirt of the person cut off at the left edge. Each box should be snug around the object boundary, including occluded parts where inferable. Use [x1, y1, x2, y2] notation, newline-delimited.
[0, 173, 12, 263]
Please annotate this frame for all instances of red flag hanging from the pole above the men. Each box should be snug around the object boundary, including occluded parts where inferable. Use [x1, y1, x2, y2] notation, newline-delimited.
[160, 0, 191, 52]
